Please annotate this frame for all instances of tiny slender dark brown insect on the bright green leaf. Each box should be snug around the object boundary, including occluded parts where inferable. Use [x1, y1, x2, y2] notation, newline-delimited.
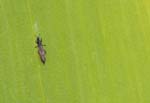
[36, 36, 46, 64]
